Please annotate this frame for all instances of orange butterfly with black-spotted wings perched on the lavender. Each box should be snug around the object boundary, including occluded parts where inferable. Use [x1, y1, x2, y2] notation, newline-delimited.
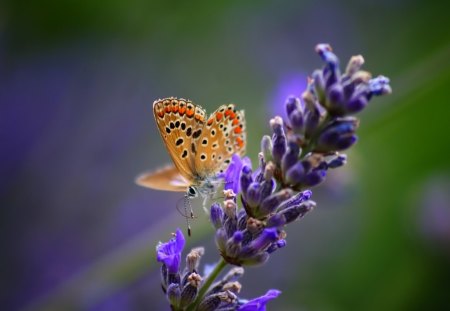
[136, 97, 246, 198]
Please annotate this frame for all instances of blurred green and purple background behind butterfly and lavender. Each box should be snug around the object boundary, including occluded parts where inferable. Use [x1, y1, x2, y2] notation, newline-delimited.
[0, 0, 450, 311]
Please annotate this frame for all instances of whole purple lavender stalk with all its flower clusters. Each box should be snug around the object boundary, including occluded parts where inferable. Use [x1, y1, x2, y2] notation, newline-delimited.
[157, 44, 391, 310]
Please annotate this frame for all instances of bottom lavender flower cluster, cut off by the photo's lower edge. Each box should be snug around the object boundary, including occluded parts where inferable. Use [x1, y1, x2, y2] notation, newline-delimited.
[156, 229, 280, 311]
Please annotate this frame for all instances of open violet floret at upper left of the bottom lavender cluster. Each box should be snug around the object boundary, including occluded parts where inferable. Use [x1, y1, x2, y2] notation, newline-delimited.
[156, 229, 186, 273]
